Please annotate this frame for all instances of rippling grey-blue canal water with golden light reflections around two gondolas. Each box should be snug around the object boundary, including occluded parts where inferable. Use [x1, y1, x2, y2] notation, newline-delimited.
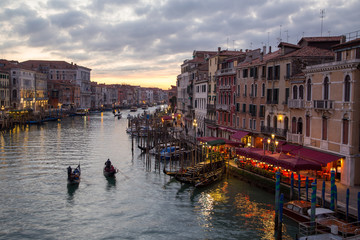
[0, 108, 297, 240]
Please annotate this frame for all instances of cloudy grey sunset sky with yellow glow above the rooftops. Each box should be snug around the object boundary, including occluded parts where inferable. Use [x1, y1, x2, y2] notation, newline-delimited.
[0, 0, 360, 89]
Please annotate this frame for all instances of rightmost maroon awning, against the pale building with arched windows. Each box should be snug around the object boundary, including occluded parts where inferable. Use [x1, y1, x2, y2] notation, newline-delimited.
[290, 147, 344, 166]
